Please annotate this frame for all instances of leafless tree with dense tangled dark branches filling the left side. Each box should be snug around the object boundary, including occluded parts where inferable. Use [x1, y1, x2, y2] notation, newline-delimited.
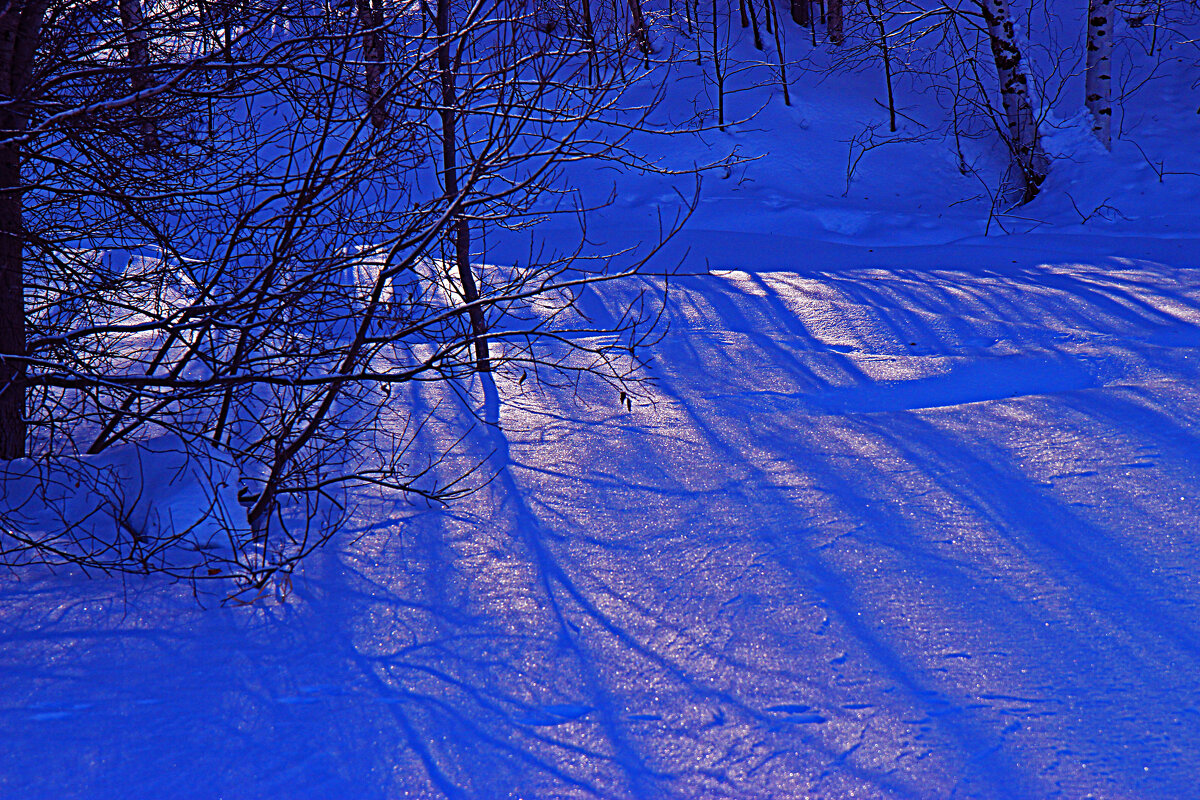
[0, 0, 691, 588]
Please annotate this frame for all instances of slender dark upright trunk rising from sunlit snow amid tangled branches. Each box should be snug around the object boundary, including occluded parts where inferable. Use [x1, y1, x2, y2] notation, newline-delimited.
[434, 0, 492, 372]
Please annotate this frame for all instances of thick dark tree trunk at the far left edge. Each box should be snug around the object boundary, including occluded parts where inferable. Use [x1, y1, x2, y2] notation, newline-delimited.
[0, 0, 49, 459]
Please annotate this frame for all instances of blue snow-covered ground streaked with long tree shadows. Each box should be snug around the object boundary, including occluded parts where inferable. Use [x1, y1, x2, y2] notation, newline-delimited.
[0, 6, 1200, 800]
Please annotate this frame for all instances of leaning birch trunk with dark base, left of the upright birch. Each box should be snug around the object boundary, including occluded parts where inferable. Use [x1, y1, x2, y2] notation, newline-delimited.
[982, 0, 1050, 203]
